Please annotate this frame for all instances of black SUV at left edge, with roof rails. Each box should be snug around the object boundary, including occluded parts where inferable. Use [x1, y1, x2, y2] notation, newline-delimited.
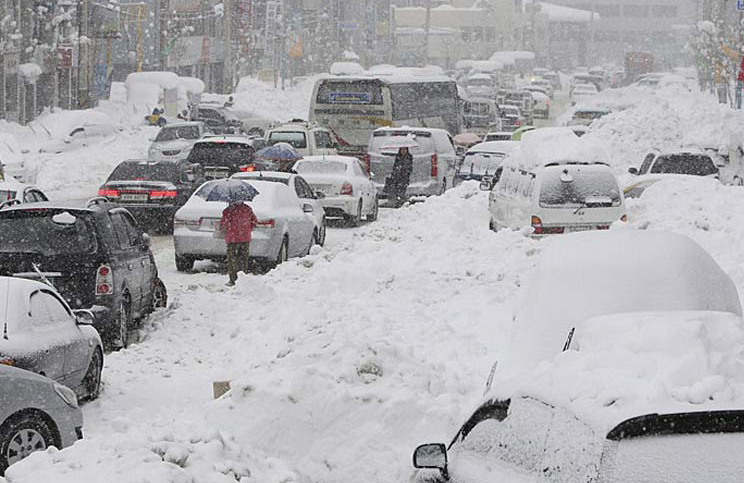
[0, 198, 167, 347]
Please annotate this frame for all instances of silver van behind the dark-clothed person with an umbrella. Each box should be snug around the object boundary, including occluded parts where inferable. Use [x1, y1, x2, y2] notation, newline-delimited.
[365, 126, 457, 200]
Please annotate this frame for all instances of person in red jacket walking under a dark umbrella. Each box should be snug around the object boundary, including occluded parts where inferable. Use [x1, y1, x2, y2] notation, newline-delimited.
[220, 201, 258, 286]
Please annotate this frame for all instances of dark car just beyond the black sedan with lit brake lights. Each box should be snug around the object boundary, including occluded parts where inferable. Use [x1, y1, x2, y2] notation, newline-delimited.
[186, 136, 268, 180]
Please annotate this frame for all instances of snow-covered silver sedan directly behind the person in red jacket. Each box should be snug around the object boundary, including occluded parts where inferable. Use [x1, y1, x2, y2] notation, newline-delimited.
[173, 180, 315, 271]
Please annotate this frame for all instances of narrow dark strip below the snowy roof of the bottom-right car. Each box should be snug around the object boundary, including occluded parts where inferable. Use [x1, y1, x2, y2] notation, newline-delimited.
[607, 410, 744, 441]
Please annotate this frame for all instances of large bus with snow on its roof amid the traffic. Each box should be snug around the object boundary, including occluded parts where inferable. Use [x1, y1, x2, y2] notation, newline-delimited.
[309, 75, 462, 157]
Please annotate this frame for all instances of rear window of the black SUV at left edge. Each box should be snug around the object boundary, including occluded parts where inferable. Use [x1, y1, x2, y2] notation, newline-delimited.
[0, 210, 96, 257]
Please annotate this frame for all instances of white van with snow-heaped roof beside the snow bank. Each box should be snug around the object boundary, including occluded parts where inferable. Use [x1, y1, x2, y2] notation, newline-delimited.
[481, 161, 626, 236]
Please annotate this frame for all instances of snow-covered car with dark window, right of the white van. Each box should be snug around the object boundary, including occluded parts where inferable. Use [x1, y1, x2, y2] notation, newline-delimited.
[623, 149, 719, 198]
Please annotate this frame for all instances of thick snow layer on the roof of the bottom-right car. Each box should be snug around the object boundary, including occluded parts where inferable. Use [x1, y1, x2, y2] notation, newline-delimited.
[494, 312, 744, 431]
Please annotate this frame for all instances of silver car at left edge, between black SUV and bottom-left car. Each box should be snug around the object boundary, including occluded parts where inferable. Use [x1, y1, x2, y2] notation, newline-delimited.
[0, 273, 103, 399]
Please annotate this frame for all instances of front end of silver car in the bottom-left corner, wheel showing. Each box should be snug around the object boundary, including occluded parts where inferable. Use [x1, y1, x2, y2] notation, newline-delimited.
[0, 364, 83, 476]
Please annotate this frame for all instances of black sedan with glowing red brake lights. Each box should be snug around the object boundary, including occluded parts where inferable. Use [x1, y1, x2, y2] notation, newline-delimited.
[98, 160, 204, 233]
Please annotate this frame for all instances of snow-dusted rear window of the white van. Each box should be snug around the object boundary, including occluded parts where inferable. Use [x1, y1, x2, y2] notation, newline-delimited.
[540, 166, 622, 208]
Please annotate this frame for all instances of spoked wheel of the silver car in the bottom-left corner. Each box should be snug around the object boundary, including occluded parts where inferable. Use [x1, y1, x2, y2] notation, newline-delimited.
[0, 414, 56, 475]
